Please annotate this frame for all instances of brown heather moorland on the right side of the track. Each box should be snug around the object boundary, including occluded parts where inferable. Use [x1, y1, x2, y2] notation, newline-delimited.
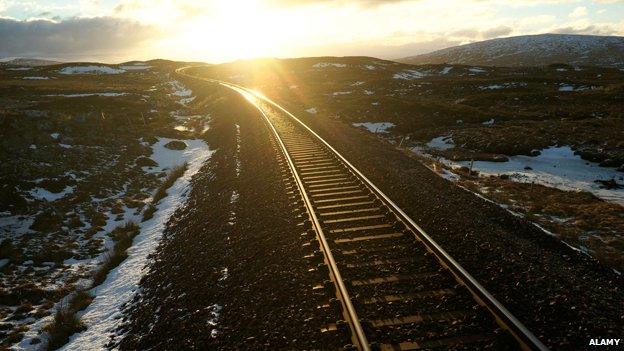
[195, 57, 624, 270]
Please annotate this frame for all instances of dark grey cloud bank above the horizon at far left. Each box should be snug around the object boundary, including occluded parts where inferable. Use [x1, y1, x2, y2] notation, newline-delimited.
[0, 17, 158, 58]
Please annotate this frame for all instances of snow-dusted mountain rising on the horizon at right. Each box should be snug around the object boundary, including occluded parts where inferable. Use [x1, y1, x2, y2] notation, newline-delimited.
[397, 34, 624, 67]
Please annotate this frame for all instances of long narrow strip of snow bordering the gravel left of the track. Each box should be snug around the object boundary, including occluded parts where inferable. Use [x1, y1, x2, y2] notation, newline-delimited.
[61, 141, 218, 350]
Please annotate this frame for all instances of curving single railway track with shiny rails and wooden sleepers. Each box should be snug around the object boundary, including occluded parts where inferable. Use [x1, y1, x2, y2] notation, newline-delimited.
[178, 70, 547, 350]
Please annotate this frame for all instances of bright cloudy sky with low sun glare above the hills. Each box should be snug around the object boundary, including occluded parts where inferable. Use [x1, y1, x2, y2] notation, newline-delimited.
[0, 0, 624, 63]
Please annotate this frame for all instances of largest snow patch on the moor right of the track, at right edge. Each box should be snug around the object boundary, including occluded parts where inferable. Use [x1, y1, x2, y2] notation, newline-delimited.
[446, 146, 624, 205]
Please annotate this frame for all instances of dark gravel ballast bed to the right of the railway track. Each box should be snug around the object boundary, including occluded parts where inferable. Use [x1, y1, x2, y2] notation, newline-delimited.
[304, 116, 624, 349]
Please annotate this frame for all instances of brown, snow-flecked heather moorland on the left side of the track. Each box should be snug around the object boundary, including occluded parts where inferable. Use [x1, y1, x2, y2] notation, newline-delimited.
[0, 61, 209, 348]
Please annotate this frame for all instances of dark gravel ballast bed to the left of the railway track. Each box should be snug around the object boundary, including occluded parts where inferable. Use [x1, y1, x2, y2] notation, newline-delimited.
[118, 91, 349, 350]
